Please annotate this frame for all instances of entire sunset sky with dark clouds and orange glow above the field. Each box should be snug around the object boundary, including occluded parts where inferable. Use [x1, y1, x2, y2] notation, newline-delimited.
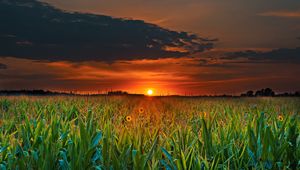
[0, 0, 300, 95]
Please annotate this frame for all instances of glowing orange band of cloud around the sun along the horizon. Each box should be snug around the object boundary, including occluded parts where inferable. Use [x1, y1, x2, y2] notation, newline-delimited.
[0, 51, 300, 95]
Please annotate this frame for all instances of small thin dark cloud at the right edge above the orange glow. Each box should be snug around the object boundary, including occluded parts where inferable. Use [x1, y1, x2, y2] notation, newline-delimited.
[222, 47, 300, 63]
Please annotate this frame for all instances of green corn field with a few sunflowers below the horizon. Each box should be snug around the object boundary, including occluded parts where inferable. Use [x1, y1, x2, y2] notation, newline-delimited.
[0, 96, 300, 170]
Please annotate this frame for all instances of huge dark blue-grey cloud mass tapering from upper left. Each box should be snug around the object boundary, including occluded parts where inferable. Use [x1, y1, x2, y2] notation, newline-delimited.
[0, 0, 216, 62]
